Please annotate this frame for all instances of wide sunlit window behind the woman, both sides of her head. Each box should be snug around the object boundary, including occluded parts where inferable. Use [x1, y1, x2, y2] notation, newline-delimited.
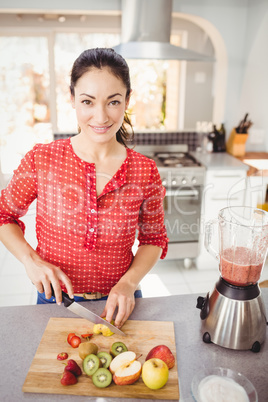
[0, 31, 184, 175]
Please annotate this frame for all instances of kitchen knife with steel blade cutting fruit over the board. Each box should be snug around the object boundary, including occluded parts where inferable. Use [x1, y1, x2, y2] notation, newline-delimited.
[51, 286, 126, 336]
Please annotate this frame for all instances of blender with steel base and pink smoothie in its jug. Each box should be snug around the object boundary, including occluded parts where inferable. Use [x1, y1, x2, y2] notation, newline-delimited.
[196, 206, 268, 352]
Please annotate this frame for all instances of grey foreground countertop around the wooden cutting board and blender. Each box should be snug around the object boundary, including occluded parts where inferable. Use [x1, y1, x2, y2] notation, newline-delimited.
[0, 289, 268, 402]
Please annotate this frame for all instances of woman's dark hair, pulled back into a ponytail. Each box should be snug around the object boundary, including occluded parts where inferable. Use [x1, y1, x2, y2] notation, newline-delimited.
[70, 48, 134, 146]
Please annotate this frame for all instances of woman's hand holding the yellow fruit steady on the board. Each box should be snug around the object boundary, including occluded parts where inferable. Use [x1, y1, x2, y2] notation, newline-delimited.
[101, 281, 135, 328]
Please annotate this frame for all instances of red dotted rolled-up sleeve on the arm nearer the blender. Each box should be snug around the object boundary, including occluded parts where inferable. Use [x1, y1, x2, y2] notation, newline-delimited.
[138, 164, 168, 259]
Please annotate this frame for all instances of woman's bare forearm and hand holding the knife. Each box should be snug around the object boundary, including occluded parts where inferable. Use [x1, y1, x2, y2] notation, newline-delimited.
[0, 223, 73, 304]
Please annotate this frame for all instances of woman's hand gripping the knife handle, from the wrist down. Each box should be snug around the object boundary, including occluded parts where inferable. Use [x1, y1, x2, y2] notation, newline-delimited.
[22, 250, 73, 304]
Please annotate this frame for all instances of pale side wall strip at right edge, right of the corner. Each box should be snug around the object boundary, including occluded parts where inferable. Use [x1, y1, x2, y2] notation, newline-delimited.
[238, 0, 268, 151]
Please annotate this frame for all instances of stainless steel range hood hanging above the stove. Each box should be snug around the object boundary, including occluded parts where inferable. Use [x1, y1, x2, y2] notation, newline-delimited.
[114, 0, 215, 62]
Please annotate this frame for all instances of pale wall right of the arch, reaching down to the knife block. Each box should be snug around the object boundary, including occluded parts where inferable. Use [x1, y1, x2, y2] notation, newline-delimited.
[173, 0, 268, 152]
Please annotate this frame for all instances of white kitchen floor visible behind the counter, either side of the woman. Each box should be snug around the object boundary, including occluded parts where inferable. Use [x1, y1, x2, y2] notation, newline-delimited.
[0, 239, 268, 306]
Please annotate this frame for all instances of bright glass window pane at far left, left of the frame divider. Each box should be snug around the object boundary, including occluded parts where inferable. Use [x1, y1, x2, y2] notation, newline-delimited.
[0, 36, 52, 173]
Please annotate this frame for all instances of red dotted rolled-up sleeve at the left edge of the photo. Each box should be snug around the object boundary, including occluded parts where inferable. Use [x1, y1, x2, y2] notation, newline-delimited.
[0, 150, 37, 232]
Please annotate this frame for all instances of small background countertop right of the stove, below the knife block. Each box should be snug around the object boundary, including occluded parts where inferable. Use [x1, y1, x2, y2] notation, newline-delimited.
[191, 152, 249, 170]
